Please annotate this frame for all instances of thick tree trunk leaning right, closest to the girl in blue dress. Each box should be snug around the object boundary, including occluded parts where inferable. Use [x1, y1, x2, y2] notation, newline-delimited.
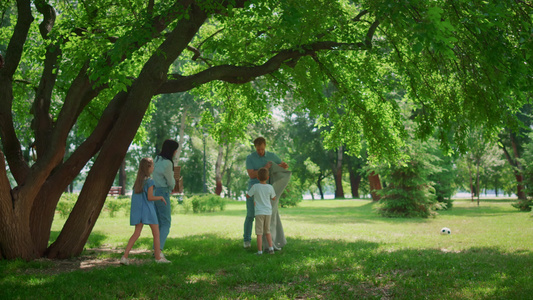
[47, 8, 207, 258]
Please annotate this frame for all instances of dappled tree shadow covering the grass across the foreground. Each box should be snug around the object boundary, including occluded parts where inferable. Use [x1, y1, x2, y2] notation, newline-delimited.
[0, 234, 533, 299]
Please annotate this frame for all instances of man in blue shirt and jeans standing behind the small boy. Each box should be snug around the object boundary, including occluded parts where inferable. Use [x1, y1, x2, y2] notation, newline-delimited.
[243, 137, 289, 248]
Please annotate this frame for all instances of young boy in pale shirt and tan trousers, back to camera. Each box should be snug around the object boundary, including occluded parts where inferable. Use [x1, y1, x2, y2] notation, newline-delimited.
[246, 168, 276, 254]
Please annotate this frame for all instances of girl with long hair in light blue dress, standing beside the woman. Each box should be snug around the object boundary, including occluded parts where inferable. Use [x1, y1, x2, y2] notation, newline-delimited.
[120, 157, 170, 265]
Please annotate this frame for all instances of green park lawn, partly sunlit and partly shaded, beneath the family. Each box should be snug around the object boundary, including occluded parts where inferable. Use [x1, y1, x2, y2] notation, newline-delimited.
[0, 200, 533, 299]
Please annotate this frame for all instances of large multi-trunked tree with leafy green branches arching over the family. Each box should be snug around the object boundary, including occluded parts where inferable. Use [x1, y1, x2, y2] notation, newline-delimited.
[0, 0, 533, 259]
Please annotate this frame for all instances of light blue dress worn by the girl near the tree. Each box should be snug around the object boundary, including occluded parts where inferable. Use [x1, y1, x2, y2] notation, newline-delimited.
[130, 178, 159, 226]
